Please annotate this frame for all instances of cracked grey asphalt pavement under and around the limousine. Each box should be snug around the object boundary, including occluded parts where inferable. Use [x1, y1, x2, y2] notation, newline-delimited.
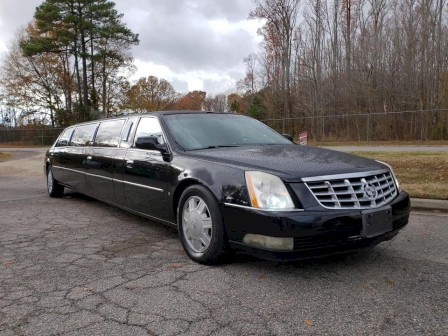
[0, 151, 448, 336]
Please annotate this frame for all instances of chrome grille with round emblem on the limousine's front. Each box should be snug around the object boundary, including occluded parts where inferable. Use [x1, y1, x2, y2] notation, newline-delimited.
[303, 171, 397, 209]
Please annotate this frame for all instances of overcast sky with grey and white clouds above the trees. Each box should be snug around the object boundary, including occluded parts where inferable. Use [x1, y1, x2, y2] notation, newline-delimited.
[0, 0, 261, 94]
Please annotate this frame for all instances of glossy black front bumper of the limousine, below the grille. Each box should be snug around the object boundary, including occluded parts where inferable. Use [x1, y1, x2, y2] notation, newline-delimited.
[222, 191, 411, 260]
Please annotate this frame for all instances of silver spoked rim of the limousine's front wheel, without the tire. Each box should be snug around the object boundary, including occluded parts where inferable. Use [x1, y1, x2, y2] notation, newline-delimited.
[182, 196, 213, 253]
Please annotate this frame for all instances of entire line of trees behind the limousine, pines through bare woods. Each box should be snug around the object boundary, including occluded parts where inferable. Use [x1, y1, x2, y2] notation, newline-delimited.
[0, 0, 448, 139]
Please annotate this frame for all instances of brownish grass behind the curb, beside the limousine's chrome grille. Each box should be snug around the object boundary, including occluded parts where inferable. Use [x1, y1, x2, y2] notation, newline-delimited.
[352, 152, 448, 200]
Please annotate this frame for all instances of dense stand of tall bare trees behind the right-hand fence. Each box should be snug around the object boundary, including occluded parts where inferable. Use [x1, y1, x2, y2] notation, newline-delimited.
[234, 0, 448, 139]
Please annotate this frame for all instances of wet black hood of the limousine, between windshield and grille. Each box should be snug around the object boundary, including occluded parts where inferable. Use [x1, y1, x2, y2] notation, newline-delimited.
[189, 145, 385, 182]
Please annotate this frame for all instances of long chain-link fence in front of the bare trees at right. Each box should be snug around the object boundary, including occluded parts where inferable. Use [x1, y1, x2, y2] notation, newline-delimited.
[262, 109, 448, 142]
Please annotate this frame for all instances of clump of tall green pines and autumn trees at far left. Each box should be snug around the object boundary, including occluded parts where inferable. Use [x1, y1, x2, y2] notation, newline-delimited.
[1, 0, 139, 126]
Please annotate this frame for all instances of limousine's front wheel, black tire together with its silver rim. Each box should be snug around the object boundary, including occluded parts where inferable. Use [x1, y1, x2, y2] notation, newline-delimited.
[177, 185, 227, 265]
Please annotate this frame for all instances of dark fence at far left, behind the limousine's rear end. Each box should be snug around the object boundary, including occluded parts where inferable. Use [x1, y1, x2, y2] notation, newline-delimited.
[0, 127, 63, 146]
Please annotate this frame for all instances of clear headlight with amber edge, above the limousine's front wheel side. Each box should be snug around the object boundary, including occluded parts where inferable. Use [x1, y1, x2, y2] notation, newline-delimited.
[246, 171, 295, 210]
